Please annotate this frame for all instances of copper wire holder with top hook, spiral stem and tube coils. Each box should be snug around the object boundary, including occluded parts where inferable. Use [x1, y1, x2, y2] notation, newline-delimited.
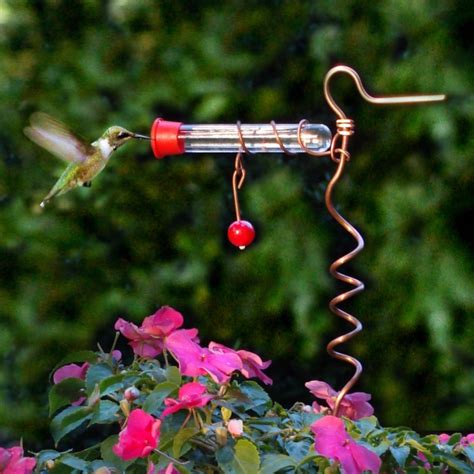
[232, 66, 446, 416]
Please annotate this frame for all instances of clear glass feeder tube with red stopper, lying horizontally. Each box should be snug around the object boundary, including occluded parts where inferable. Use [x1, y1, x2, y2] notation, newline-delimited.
[151, 118, 331, 158]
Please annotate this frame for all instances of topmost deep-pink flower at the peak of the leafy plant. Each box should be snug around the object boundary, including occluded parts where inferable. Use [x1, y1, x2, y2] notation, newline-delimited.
[114, 306, 187, 358]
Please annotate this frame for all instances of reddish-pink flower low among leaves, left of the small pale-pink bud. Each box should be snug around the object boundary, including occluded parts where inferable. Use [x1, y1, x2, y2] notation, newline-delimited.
[112, 408, 161, 461]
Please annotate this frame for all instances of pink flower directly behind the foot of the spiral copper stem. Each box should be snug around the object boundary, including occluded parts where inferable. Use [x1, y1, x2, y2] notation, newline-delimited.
[305, 380, 374, 420]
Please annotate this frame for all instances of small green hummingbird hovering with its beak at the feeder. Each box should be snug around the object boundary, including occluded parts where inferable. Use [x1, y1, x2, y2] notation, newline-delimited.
[24, 112, 150, 207]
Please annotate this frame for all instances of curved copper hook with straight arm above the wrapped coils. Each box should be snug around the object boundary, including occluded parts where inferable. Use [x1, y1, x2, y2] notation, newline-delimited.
[324, 66, 446, 119]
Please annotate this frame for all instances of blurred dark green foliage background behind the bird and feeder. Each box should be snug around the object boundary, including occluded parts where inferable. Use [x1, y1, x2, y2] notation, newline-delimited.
[0, 0, 474, 446]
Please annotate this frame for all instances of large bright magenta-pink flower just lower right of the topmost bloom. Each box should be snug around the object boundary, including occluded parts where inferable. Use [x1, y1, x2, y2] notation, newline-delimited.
[166, 329, 242, 384]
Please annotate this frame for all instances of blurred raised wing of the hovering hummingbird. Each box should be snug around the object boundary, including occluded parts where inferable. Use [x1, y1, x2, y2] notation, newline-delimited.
[24, 112, 94, 163]
